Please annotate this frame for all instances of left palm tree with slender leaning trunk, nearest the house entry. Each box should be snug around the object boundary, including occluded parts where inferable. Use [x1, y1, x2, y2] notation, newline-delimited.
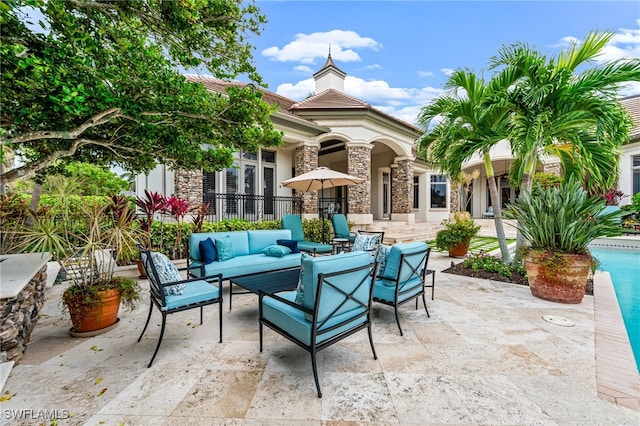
[418, 70, 511, 263]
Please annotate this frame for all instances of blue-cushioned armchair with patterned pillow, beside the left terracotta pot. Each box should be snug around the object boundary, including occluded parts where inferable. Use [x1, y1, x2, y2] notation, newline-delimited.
[138, 250, 222, 368]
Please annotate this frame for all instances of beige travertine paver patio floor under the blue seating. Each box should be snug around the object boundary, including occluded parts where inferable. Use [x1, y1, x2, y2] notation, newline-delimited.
[1, 253, 640, 425]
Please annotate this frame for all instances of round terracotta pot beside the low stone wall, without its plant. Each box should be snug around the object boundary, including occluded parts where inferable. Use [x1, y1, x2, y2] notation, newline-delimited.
[65, 290, 120, 333]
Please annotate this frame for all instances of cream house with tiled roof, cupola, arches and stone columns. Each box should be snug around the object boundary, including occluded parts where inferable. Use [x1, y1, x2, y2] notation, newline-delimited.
[136, 54, 450, 225]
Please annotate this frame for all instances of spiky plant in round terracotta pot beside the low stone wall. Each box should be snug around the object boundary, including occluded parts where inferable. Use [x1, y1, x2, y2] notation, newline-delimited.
[21, 191, 141, 337]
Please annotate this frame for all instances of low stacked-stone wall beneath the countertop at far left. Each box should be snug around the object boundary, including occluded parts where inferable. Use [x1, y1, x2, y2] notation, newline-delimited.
[0, 265, 47, 362]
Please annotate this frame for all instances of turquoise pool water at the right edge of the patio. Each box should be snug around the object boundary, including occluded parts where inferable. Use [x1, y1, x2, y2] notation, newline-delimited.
[590, 248, 640, 371]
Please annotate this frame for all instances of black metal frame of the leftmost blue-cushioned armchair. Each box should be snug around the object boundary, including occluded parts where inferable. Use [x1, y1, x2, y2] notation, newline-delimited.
[138, 250, 222, 368]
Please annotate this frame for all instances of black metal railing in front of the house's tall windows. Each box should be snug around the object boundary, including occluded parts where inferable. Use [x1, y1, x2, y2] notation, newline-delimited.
[203, 193, 302, 222]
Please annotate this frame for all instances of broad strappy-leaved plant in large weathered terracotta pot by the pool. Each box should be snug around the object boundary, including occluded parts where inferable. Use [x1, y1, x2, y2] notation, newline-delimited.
[504, 179, 621, 303]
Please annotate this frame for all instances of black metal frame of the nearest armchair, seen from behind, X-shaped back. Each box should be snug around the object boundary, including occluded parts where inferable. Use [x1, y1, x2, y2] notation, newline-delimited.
[259, 262, 378, 398]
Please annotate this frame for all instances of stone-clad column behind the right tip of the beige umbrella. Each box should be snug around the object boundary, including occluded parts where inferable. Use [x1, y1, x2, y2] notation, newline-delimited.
[347, 143, 373, 215]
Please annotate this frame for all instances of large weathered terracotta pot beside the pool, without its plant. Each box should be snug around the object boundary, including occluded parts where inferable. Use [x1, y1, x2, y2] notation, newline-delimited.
[524, 251, 592, 303]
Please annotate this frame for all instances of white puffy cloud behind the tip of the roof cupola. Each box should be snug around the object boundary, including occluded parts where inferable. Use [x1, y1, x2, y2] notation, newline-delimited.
[262, 30, 382, 64]
